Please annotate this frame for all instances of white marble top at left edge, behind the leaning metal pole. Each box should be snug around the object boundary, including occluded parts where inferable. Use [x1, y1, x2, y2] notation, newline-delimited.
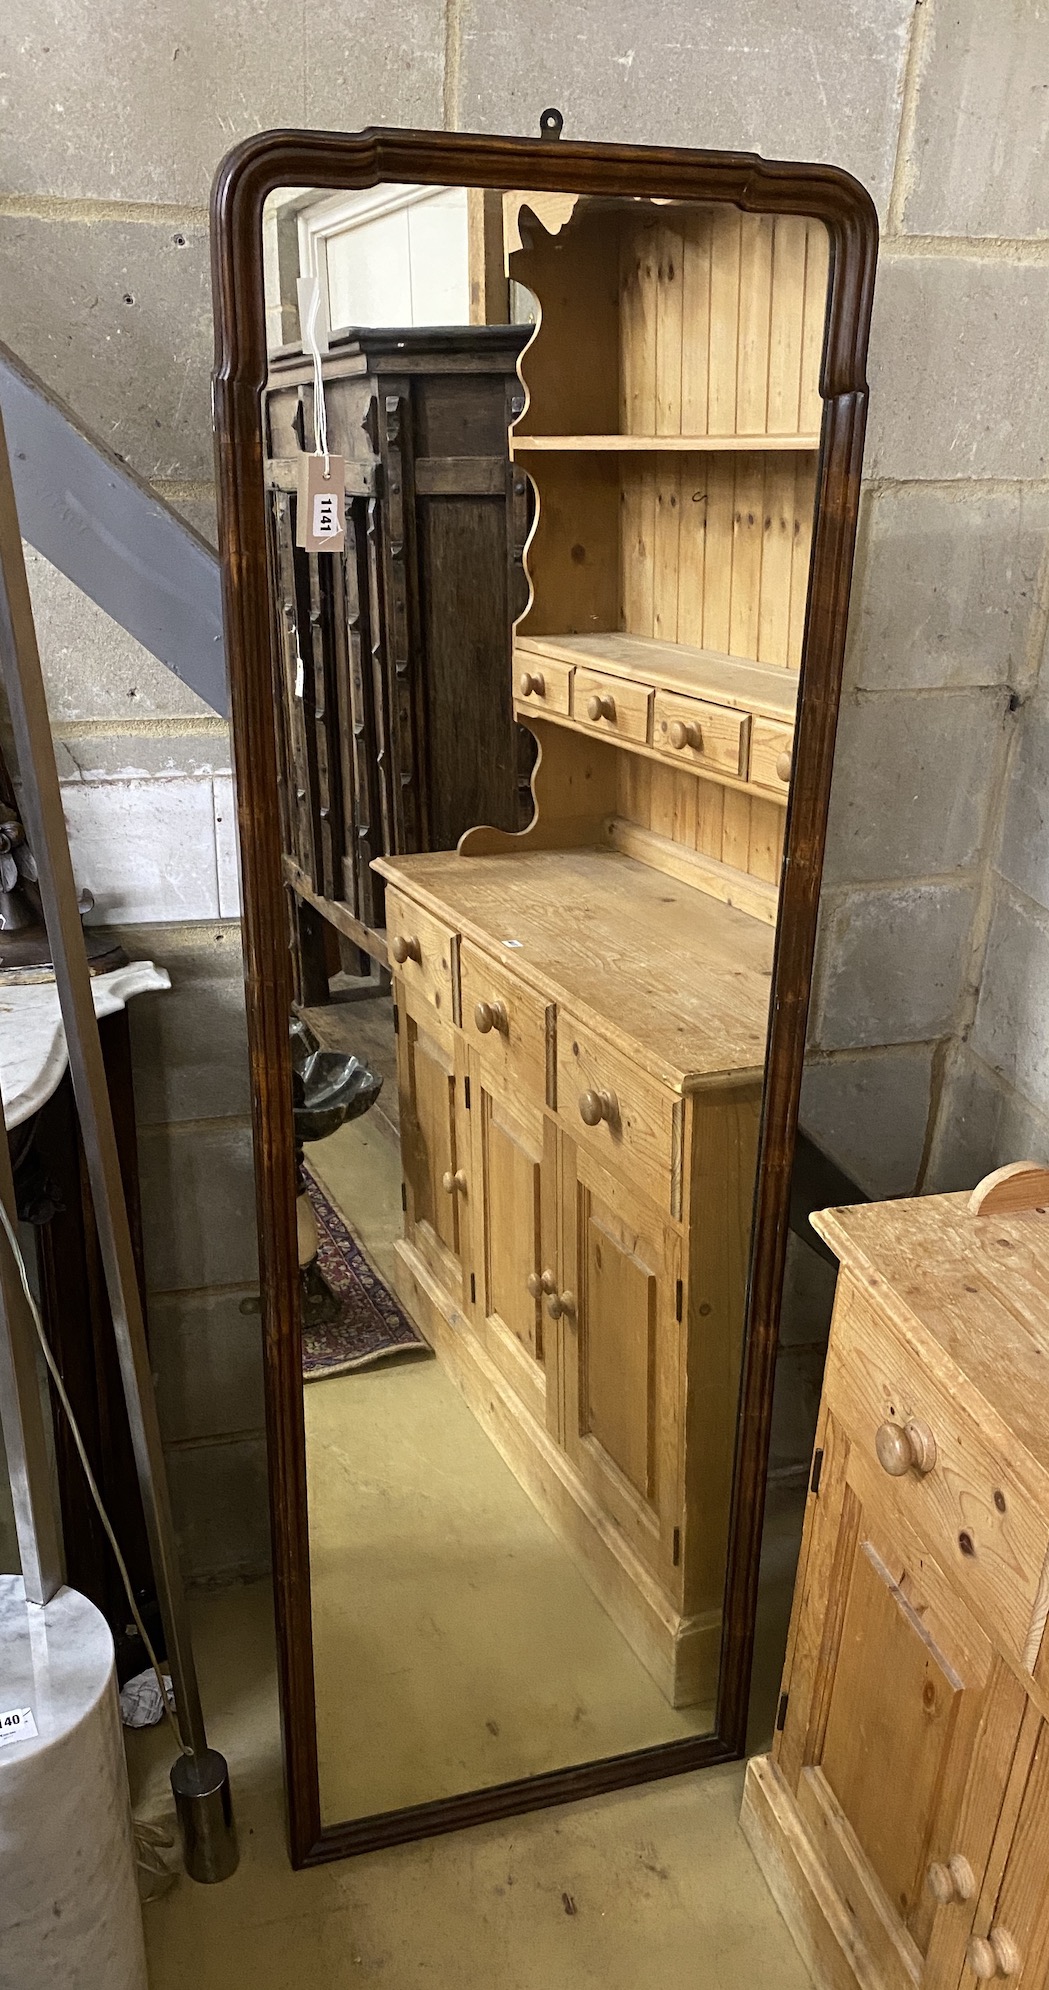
[0, 961, 171, 1126]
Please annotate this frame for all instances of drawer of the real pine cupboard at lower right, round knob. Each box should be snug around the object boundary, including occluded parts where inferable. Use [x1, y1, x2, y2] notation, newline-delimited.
[824, 1278, 1049, 1672]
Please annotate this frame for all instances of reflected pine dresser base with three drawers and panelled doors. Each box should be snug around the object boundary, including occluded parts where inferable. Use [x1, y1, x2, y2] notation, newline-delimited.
[384, 852, 770, 1705]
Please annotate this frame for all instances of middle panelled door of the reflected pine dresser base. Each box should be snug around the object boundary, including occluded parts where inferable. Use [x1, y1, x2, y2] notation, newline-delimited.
[470, 1055, 557, 1429]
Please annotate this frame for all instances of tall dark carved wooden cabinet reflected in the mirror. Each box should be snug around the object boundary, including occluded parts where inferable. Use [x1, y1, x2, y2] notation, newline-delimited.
[265, 324, 529, 999]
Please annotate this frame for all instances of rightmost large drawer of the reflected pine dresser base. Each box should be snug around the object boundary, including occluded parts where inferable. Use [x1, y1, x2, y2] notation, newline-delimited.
[557, 1009, 683, 1218]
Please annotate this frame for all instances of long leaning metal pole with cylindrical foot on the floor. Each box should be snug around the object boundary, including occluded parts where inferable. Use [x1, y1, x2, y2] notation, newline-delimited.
[0, 407, 237, 1879]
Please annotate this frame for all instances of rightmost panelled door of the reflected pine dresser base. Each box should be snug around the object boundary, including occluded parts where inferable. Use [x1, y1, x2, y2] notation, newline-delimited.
[545, 1140, 685, 1594]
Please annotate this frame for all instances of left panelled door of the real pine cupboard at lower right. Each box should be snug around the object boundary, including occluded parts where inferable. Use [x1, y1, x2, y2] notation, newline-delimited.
[774, 1409, 1023, 1990]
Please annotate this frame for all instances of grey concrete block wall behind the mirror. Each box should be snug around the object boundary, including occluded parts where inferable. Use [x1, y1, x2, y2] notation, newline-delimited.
[0, 0, 1049, 1576]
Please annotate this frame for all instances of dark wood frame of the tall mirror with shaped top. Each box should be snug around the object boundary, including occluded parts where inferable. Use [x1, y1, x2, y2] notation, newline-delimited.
[211, 129, 878, 1867]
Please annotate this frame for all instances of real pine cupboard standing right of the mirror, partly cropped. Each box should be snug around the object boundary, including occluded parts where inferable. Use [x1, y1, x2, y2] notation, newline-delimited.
[742, 1196, 1049, 1990]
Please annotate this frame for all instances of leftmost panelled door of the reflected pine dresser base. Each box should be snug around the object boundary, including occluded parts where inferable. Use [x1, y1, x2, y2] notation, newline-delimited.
[394, 977, 470, 1305]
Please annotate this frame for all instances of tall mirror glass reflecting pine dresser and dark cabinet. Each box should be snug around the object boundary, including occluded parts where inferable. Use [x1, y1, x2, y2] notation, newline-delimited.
[265, 185, 828, 1823]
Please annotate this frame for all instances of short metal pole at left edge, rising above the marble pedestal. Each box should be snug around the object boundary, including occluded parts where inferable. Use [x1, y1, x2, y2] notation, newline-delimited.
[0, 1108, 64, 1604]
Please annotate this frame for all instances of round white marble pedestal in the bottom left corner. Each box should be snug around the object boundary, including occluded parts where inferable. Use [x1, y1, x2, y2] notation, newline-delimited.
[0, 1576, 147, 1990]
